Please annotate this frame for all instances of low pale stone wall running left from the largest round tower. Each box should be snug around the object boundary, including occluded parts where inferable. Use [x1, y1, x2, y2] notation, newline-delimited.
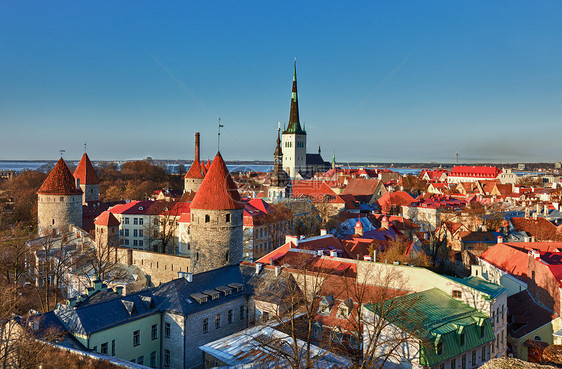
[117, 247, 189, 286]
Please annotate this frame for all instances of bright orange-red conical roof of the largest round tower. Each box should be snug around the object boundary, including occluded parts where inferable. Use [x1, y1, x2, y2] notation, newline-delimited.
[191, 152, 244, 210]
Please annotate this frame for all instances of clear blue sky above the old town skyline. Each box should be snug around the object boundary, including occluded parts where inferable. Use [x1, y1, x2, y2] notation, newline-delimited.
[0, 0, 562, 163]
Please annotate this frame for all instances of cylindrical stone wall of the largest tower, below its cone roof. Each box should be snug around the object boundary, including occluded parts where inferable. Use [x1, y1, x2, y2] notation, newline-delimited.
[191, 209, 243, 273]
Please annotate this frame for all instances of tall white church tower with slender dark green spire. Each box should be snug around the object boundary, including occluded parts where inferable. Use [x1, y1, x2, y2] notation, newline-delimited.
[282, 60, 306, 178]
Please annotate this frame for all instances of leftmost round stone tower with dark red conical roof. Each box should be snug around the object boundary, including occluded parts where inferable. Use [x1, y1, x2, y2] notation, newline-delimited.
[37, 158, 82, 235]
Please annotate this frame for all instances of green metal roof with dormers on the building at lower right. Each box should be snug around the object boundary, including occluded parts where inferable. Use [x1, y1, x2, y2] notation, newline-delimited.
[365, 288, 494, 366]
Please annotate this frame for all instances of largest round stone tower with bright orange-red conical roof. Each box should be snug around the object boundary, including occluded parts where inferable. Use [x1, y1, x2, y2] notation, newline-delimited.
[189, 152, 244, 273]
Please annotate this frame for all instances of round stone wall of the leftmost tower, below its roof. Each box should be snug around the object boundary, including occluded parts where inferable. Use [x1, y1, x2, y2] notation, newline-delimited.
[37, 195, 82, 235]
